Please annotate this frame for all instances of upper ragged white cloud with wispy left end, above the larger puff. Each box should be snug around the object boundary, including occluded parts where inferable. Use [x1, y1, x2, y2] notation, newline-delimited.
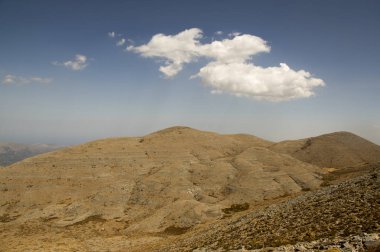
[127, 28, 270, 77]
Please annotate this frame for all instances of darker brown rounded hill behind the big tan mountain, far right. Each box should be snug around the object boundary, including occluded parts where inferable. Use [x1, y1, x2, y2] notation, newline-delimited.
[270, 132, 380, 169]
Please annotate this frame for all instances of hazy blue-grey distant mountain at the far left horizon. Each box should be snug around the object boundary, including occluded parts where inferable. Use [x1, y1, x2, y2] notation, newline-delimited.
[0, 142, 59, 167]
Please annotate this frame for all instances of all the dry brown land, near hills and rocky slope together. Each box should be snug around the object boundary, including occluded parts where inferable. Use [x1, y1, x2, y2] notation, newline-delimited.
[0, 127, 380, 251]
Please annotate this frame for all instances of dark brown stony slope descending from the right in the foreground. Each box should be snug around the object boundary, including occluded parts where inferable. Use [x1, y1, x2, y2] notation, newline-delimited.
[154, 167, 380, 251]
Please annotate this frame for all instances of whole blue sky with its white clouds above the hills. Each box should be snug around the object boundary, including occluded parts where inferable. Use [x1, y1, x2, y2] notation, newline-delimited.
[0, 0, 380, 145]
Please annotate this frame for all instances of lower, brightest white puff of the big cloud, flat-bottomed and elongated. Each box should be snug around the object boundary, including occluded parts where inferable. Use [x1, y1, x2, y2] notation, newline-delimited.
[197, 62, 324, 101]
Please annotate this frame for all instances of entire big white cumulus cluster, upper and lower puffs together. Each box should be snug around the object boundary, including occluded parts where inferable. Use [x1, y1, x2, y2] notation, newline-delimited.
[127, 28, 325, 101]
